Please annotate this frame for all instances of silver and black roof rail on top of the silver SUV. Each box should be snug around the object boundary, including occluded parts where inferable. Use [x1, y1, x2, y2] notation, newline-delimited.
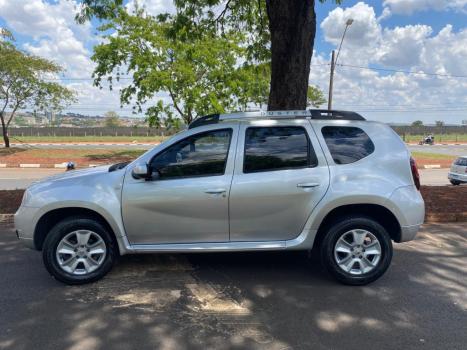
[188, 109, 365, 129]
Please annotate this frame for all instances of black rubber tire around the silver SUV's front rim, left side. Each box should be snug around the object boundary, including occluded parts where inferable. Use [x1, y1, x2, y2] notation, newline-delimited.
[42, 217, 118, 285]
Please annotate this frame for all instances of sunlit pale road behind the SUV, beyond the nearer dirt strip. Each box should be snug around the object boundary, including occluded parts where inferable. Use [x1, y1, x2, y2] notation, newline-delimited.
[0, 168, 456, 190]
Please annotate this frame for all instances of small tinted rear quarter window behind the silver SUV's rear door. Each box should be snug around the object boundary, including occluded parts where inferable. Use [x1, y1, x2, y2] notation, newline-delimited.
[321, 126, 375, 164]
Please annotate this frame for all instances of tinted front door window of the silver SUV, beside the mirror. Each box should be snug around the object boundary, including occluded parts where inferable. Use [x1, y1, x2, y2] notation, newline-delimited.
[150, 129, 232, 180]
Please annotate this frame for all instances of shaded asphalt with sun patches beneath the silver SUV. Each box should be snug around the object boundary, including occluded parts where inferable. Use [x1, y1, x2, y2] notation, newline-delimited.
[0, 225, 467, 350]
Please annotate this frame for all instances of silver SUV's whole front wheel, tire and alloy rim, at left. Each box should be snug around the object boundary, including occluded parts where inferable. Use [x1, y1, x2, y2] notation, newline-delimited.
[42, 217, 116, 284]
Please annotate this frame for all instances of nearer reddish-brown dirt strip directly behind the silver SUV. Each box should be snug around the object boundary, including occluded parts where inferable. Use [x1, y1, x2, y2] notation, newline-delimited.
[0, 186, 467, 223]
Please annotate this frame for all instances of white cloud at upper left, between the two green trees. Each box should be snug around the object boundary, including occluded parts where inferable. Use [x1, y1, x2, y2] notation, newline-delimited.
[0, 0, 130, 114]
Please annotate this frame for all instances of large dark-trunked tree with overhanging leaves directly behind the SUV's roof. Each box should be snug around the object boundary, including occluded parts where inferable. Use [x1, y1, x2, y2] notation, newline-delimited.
[76, 0, 342, 110]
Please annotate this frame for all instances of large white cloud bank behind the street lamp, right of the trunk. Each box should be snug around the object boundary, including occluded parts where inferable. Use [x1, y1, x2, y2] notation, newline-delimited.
[322, 2, 467, 121]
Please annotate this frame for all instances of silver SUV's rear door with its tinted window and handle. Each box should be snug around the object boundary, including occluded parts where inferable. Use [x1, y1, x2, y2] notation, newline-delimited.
[229, 120, 329, 241]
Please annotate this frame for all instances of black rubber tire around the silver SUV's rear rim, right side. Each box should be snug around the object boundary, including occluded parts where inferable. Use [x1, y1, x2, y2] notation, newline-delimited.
[320, 216, 393, 286]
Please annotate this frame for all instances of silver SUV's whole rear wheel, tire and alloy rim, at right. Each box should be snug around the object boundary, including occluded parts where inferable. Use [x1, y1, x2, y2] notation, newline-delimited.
[321, 216, 393, 285]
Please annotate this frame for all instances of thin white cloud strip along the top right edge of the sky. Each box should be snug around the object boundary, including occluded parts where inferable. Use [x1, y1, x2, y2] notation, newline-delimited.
[383, 0, 467, 15]
